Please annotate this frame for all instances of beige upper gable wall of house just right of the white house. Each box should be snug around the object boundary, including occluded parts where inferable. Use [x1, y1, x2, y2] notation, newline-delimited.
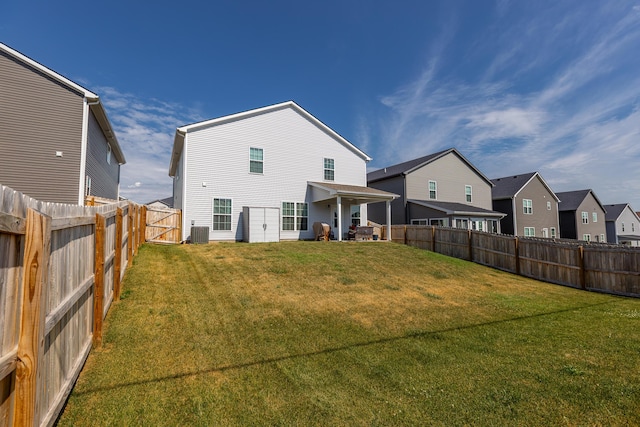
[406, 153, 493, 210]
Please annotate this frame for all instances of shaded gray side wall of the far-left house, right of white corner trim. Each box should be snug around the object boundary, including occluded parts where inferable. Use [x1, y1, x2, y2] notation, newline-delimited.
[86, 113, 120, 200]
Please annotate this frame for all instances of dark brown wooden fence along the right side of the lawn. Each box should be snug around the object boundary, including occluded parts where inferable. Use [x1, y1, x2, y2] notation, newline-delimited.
[383, 225, 640, 297]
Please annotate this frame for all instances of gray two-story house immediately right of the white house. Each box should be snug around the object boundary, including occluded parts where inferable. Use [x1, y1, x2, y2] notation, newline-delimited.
[367, 148, 504, 233]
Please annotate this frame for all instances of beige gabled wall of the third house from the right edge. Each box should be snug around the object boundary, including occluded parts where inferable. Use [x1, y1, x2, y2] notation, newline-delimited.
[514, 176, 560, 237]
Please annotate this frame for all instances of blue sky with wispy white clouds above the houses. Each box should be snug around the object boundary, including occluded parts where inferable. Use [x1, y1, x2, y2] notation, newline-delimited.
[0, 0, 640, 210]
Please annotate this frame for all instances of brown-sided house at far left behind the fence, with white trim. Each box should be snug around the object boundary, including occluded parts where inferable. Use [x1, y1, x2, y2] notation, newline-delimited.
[0, 43, 125, 205]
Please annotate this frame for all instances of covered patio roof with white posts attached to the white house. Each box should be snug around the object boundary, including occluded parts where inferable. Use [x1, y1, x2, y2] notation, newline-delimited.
[307, 181, 400, 241]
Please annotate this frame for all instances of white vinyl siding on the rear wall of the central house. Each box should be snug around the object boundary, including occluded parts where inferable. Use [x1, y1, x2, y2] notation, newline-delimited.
[180, 108, 367, 240]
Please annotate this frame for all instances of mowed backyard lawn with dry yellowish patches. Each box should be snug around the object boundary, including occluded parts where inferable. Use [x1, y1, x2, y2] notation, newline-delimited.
[59, 242, 640, 426]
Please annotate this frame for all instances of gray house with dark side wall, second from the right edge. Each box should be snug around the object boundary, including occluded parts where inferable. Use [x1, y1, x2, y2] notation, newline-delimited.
[556, 189, 607, 242]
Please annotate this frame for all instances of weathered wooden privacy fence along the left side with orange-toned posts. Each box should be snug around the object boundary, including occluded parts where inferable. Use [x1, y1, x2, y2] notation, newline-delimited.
[0, 186, 145, 426]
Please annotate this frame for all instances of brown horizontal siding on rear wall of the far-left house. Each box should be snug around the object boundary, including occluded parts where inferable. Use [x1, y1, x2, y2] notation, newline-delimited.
[0, 51, 83, 204]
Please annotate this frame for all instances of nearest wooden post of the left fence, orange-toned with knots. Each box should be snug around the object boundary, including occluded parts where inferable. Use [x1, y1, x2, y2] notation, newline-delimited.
[14, 209, 51, 426]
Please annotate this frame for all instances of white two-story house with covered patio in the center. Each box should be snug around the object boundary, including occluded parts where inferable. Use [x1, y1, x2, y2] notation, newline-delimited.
[169, 101, 397, 241]
